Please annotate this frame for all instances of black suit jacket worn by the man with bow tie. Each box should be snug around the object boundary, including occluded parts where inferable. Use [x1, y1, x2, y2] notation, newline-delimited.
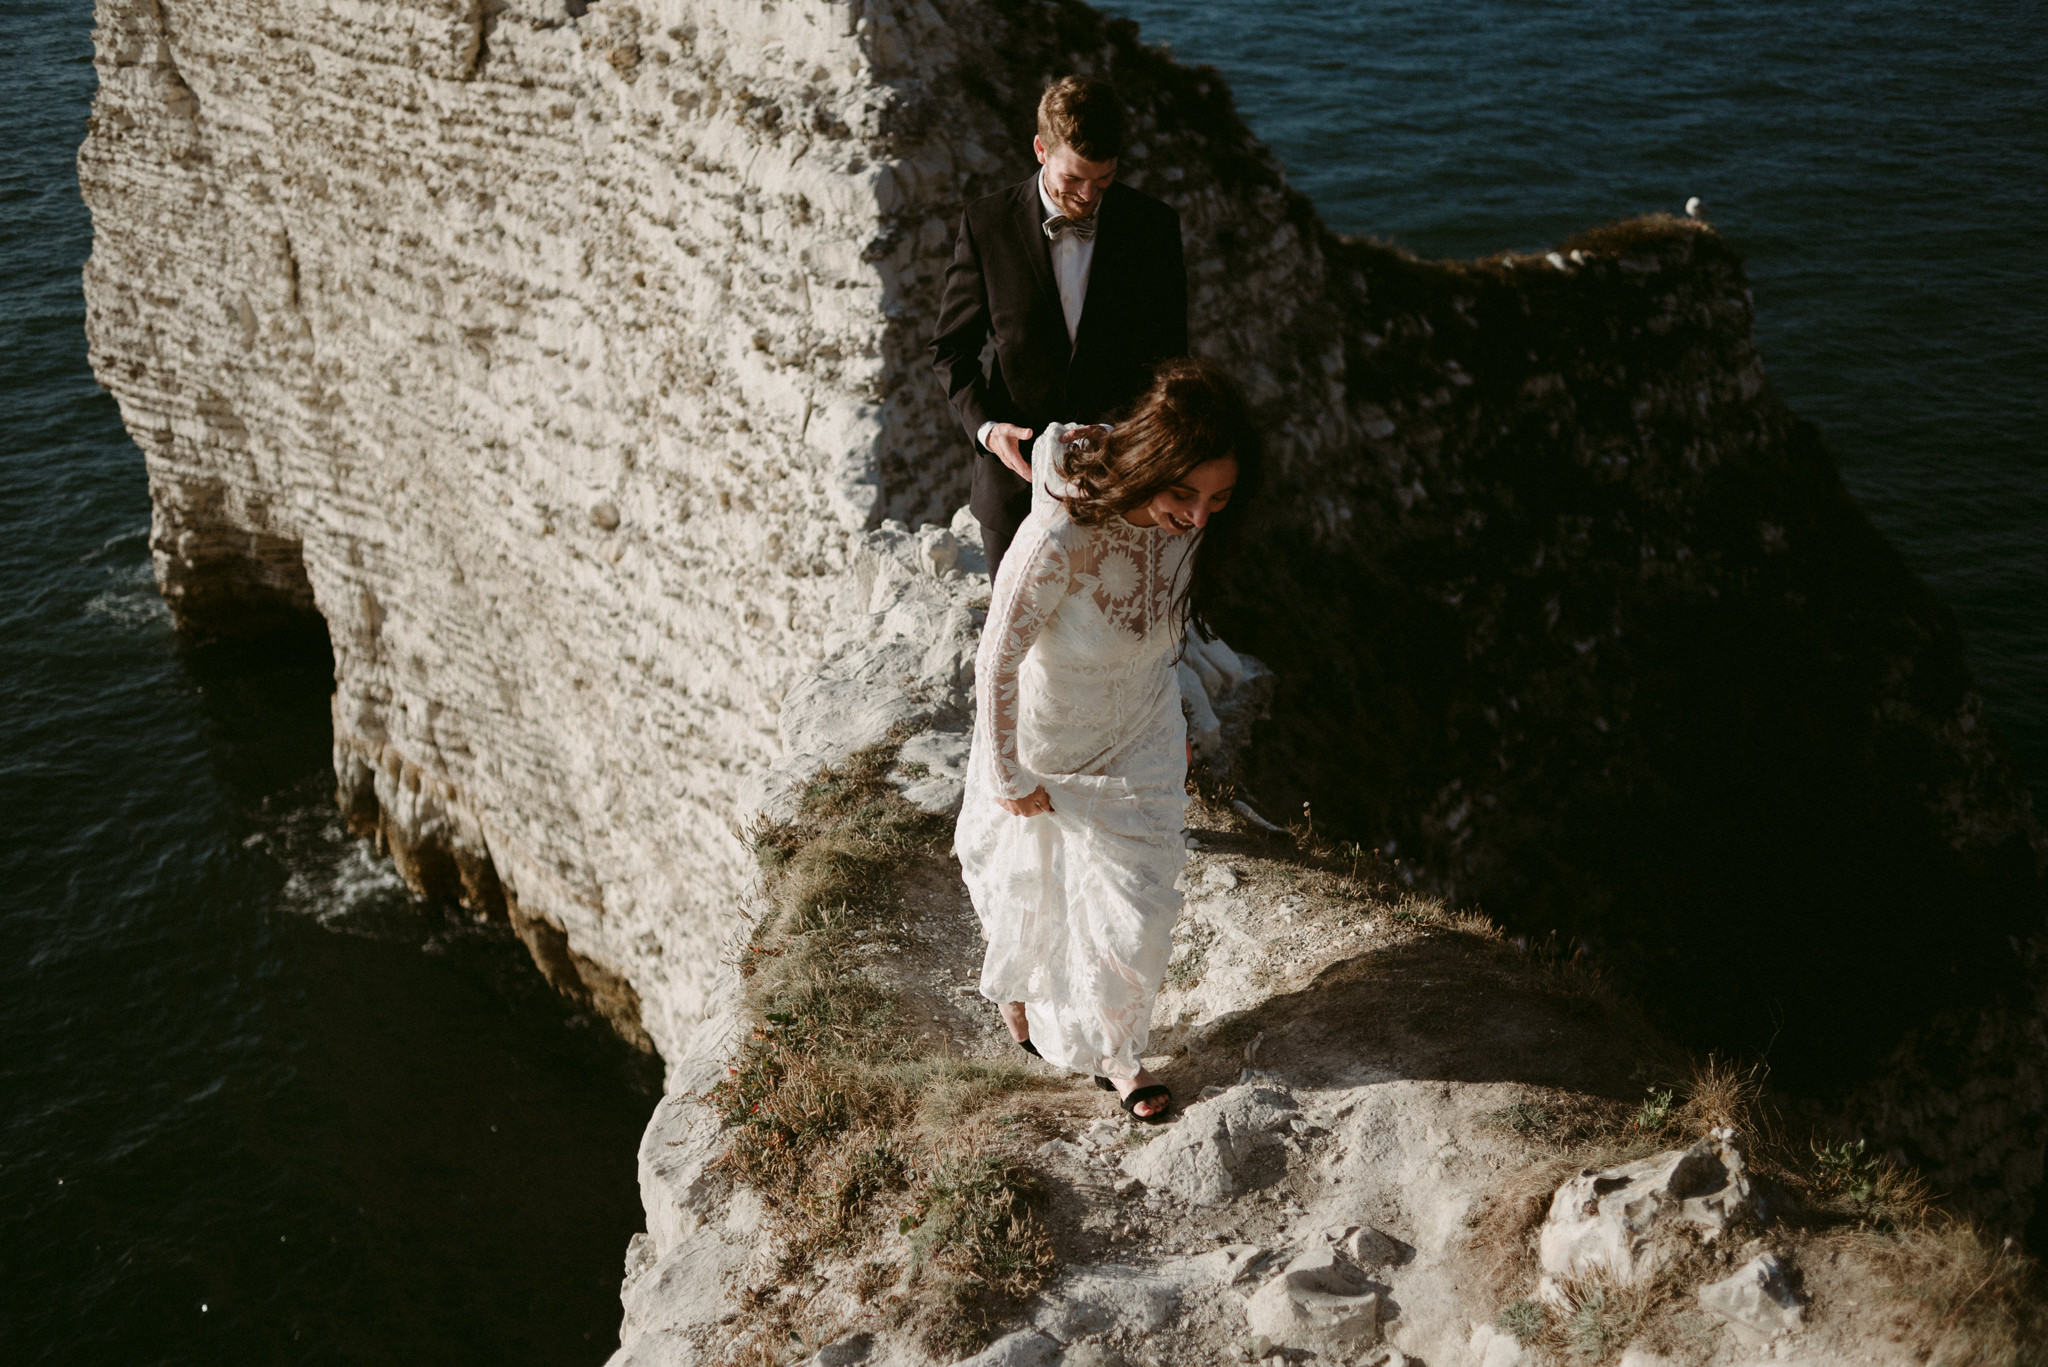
[932, 172, 1188, 531]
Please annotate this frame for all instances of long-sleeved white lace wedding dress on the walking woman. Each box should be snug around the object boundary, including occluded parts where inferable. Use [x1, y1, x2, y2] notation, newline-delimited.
[954, 424, 1200, 1076]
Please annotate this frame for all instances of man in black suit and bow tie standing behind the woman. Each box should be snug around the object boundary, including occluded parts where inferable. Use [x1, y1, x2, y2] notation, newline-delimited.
[932, 76, 1188, 578]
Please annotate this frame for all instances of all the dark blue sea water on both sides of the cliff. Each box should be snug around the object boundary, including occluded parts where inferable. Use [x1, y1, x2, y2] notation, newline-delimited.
[0, 0, 2048, 1367]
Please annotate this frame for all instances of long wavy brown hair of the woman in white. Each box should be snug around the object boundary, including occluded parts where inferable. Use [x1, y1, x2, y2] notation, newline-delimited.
[1063, 357, 1264, 629]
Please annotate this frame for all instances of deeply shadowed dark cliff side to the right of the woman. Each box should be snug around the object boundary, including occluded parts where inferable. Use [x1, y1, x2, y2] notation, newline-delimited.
[1171, 221, 2048, 1224]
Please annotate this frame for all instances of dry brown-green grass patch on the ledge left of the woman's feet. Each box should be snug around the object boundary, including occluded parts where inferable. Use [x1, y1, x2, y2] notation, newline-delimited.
[707, 736, 1053, 1367]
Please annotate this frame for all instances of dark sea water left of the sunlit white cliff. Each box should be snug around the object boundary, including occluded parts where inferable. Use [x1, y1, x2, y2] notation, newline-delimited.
[0, 10, 659, 1367]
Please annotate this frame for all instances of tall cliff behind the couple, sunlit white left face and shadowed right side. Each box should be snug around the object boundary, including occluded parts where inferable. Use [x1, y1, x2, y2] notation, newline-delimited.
[80, 0, 2048, 1221]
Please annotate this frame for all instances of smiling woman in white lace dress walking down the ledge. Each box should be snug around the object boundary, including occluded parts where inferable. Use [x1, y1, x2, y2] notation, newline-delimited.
[954, 361, 1260, 1121]
